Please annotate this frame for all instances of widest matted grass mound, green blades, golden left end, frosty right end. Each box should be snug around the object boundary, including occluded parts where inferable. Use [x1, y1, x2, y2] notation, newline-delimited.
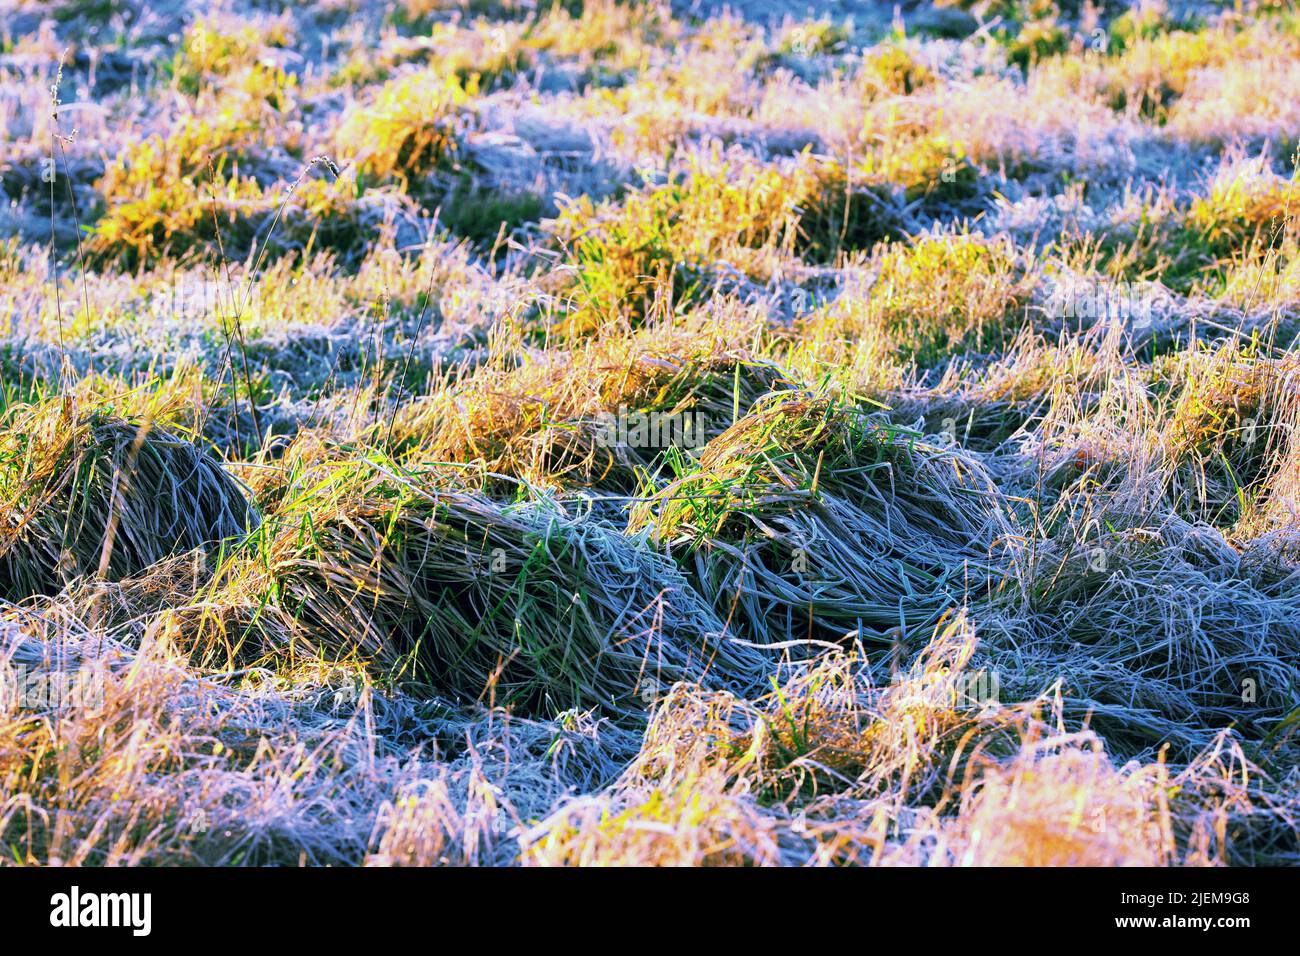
[221, 462, 764, 717]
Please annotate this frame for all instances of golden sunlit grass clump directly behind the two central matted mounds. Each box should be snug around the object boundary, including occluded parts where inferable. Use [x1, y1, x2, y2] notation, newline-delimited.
[385, 311, 788, 493]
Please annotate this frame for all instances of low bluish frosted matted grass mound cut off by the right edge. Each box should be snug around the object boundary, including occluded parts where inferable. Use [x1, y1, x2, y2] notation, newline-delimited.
[1008, 516, 1300, 757]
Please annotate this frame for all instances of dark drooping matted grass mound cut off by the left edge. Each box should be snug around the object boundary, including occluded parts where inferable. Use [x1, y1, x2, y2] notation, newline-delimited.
[0, 402, 256, 601]
